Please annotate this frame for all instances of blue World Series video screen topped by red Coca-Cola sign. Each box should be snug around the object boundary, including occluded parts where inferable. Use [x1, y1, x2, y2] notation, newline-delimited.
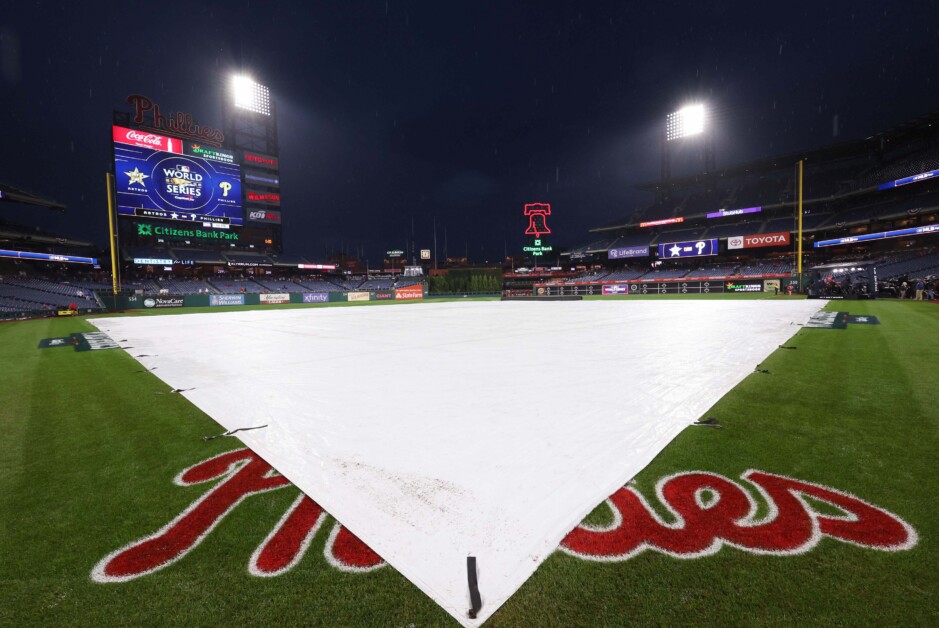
[112, 126, 243, 226]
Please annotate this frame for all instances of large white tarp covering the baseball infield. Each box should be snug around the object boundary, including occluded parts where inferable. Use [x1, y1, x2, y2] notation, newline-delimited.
[92, 299, 824, 626]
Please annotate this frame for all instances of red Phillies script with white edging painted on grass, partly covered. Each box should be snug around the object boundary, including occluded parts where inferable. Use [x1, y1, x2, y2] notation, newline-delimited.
[91, 449, 917, 582]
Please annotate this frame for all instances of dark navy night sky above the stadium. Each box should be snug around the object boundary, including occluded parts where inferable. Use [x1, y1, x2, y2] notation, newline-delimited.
[0, 0, 939, 262]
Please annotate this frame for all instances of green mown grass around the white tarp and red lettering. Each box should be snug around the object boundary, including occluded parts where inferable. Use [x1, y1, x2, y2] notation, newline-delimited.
[0, 295, 939, 626]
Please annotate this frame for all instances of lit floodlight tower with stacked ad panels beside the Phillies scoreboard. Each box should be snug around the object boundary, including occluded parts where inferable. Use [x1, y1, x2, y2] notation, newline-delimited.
[222, 74, 283, 253]
